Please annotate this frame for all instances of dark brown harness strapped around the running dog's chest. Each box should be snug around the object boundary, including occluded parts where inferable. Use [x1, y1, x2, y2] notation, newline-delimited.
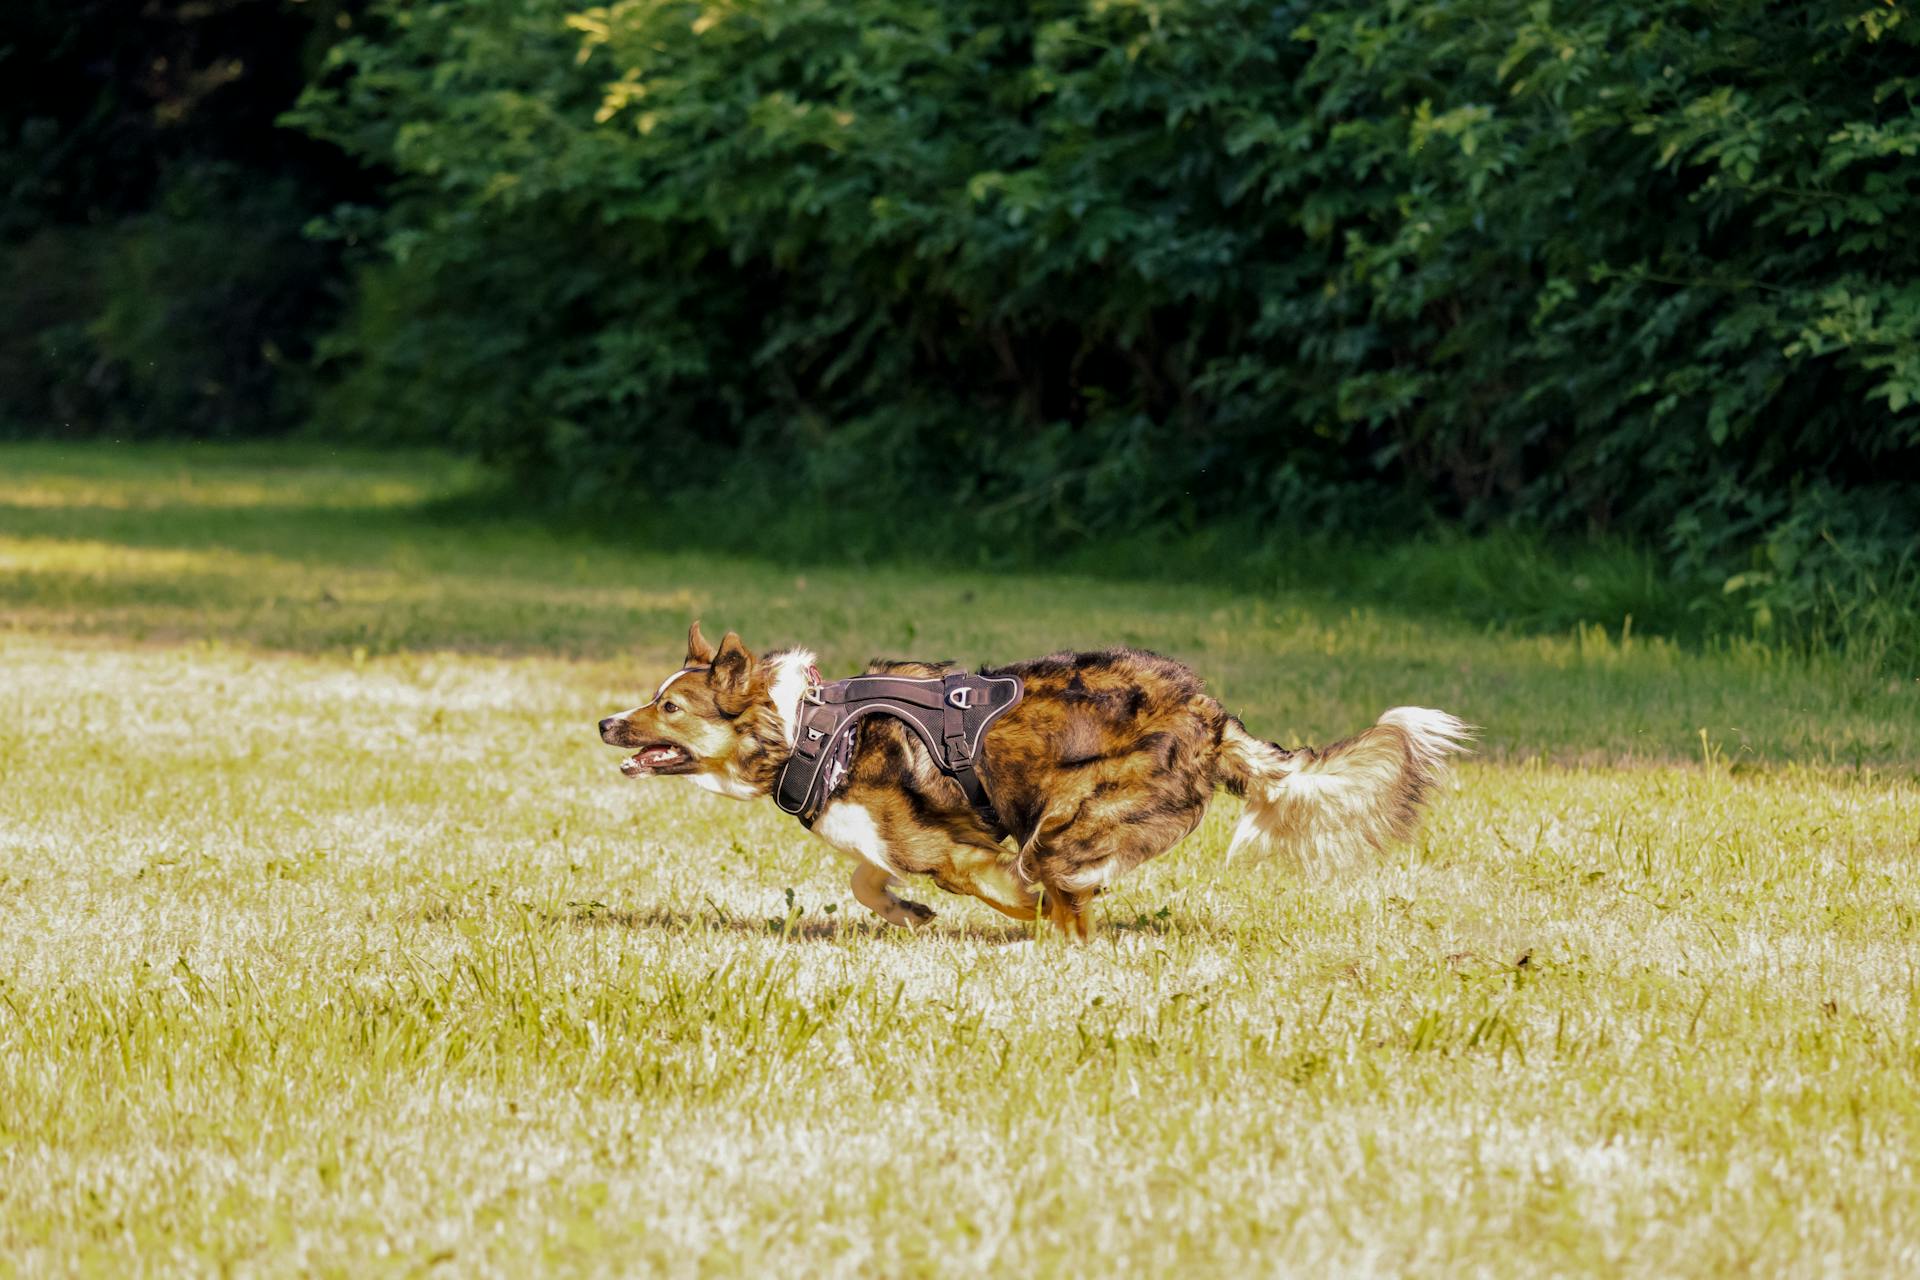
[774, 672, 1023, 831]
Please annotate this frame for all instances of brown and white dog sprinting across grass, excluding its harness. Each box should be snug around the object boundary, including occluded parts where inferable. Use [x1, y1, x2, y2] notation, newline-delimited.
[599, 622, 1473, 938]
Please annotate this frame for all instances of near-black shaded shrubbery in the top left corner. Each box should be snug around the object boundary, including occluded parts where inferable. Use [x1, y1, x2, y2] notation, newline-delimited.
[0, 0, 372, 434]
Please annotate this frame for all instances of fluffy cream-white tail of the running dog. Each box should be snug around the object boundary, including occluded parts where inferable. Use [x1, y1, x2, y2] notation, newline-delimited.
[1213, 706, 1475, 875]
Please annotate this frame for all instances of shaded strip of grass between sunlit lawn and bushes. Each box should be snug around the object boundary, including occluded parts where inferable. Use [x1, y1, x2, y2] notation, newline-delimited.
[0, 449, 1914, 764]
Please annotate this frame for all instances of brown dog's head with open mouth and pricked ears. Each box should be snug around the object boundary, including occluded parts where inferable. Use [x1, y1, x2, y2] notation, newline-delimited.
[599, 622, 787, 798]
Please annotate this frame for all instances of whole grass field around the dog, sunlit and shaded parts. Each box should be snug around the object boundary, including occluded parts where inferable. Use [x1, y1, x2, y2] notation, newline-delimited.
[0, 447, 1920, 1276]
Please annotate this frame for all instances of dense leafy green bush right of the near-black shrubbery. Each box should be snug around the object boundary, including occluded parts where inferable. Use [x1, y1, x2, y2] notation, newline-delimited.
[298, 0, 1920, 656]
